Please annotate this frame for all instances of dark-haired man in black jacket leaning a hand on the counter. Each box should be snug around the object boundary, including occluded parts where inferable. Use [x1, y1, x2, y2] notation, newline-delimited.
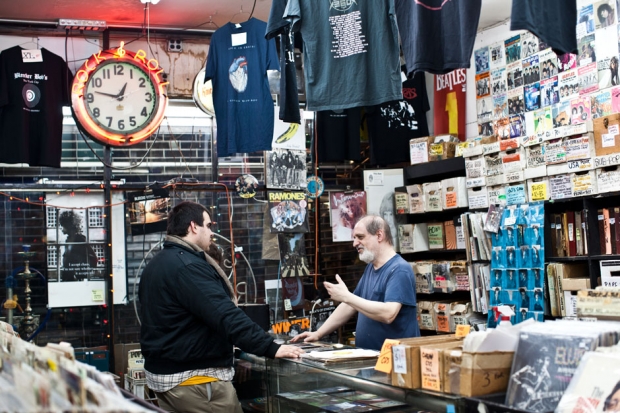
[139, 202, 302, 413]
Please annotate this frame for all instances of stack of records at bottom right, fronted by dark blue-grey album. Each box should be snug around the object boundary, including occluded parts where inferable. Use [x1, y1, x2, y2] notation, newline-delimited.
[506, 321, 620, 412]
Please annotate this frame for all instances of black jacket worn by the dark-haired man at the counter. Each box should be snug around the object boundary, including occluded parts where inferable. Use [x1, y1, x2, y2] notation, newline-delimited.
[139, 241, 279, 374]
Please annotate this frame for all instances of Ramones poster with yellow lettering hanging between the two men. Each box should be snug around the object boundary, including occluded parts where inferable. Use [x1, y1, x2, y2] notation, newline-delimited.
[267, 191, 309, 232]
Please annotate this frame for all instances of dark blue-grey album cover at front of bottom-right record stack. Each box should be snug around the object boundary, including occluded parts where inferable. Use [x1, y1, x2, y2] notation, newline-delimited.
[506, 332, 596, 412]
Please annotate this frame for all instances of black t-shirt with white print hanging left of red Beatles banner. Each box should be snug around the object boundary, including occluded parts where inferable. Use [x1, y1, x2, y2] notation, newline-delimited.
[366, 67, 430, 165]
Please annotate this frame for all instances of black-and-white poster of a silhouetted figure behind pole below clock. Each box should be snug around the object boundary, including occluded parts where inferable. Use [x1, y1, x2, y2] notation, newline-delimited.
[46, 193, 127, 308]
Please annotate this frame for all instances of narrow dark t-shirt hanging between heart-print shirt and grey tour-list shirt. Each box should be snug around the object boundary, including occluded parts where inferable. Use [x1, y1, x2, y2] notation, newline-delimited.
[265, 0, 301, 123]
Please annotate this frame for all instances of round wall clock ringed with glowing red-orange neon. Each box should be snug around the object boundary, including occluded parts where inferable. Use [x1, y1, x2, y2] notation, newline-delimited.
[71, 45, 167, 146]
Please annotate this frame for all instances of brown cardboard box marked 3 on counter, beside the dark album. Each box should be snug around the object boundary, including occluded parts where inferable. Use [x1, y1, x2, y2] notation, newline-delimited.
[448, 351, 514, 397]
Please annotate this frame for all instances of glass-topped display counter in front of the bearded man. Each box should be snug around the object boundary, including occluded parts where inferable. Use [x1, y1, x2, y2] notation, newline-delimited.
[265, 359, 465, 413]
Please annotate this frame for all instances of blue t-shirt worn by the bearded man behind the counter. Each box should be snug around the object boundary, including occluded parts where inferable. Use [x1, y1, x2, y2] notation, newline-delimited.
[353, 254, 420, 350]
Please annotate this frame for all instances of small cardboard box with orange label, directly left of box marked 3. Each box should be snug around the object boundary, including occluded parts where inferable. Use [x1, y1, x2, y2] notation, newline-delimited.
[420, 341, 462, 392]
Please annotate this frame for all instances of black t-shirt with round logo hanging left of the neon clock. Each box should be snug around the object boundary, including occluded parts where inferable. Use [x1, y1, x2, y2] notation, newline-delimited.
[0, 46, 73, 168]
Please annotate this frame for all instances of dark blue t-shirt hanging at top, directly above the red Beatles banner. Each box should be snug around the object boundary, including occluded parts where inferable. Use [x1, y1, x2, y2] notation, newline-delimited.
[395, 0, 482, 74]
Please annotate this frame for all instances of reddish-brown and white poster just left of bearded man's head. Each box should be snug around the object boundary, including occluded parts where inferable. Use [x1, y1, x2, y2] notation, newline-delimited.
[329, 191, 366, 242]
